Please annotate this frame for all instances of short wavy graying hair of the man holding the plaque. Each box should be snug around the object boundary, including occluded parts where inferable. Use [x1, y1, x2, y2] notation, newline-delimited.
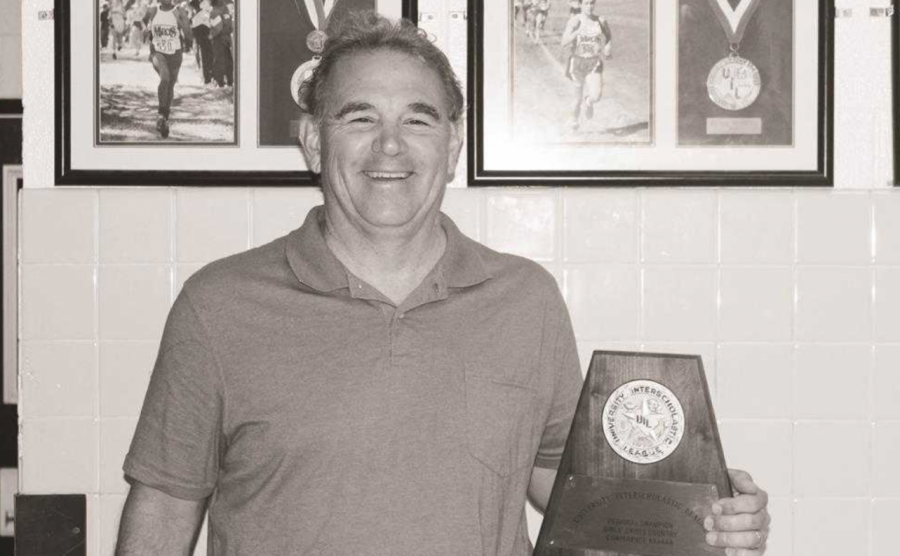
[299, 11, 464, 123]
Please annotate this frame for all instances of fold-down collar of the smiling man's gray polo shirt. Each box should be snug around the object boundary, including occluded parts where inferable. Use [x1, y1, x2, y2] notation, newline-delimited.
[285, 206, 491, 292]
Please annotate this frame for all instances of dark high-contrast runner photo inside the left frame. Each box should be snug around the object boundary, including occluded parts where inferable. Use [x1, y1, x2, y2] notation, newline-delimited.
[94, 0, 238, 145]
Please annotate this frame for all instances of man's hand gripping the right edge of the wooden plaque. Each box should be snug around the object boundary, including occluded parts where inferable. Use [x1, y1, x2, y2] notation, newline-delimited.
[703, 469, 771, 556]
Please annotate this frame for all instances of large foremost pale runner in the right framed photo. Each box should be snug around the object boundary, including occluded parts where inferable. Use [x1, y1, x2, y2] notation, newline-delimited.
[560, 0, 612, 131]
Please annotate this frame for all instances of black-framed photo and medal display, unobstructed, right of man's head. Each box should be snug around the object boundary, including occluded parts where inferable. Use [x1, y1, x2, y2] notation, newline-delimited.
[468, 0, 834, 186]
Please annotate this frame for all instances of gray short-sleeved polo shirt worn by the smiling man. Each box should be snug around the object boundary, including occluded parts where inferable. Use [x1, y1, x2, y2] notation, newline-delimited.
[124, 207, 582, 556]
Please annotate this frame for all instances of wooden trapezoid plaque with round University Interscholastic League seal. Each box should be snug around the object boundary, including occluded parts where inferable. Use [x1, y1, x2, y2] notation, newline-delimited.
[534, 351, 731, 556]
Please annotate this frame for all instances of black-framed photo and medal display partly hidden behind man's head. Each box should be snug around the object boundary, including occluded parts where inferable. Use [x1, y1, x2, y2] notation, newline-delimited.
[54, 0, 417, 185]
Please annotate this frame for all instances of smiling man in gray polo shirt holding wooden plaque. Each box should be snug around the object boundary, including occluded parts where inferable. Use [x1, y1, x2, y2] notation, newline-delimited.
[117, 14, 767, 556]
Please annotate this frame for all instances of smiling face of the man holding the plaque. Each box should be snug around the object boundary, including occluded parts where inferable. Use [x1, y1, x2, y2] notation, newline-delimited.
[312, 50, 460, 236]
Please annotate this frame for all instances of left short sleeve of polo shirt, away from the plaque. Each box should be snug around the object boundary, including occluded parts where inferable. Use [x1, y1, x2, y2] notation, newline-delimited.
[123, 290, 224, 500]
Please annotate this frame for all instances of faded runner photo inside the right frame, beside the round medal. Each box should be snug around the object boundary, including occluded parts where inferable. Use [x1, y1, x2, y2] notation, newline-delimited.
[508, 0, 653, 144]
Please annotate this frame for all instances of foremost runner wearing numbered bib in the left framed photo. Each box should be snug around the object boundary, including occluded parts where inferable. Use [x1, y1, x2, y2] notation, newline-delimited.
[147, 0, 193, 139]
